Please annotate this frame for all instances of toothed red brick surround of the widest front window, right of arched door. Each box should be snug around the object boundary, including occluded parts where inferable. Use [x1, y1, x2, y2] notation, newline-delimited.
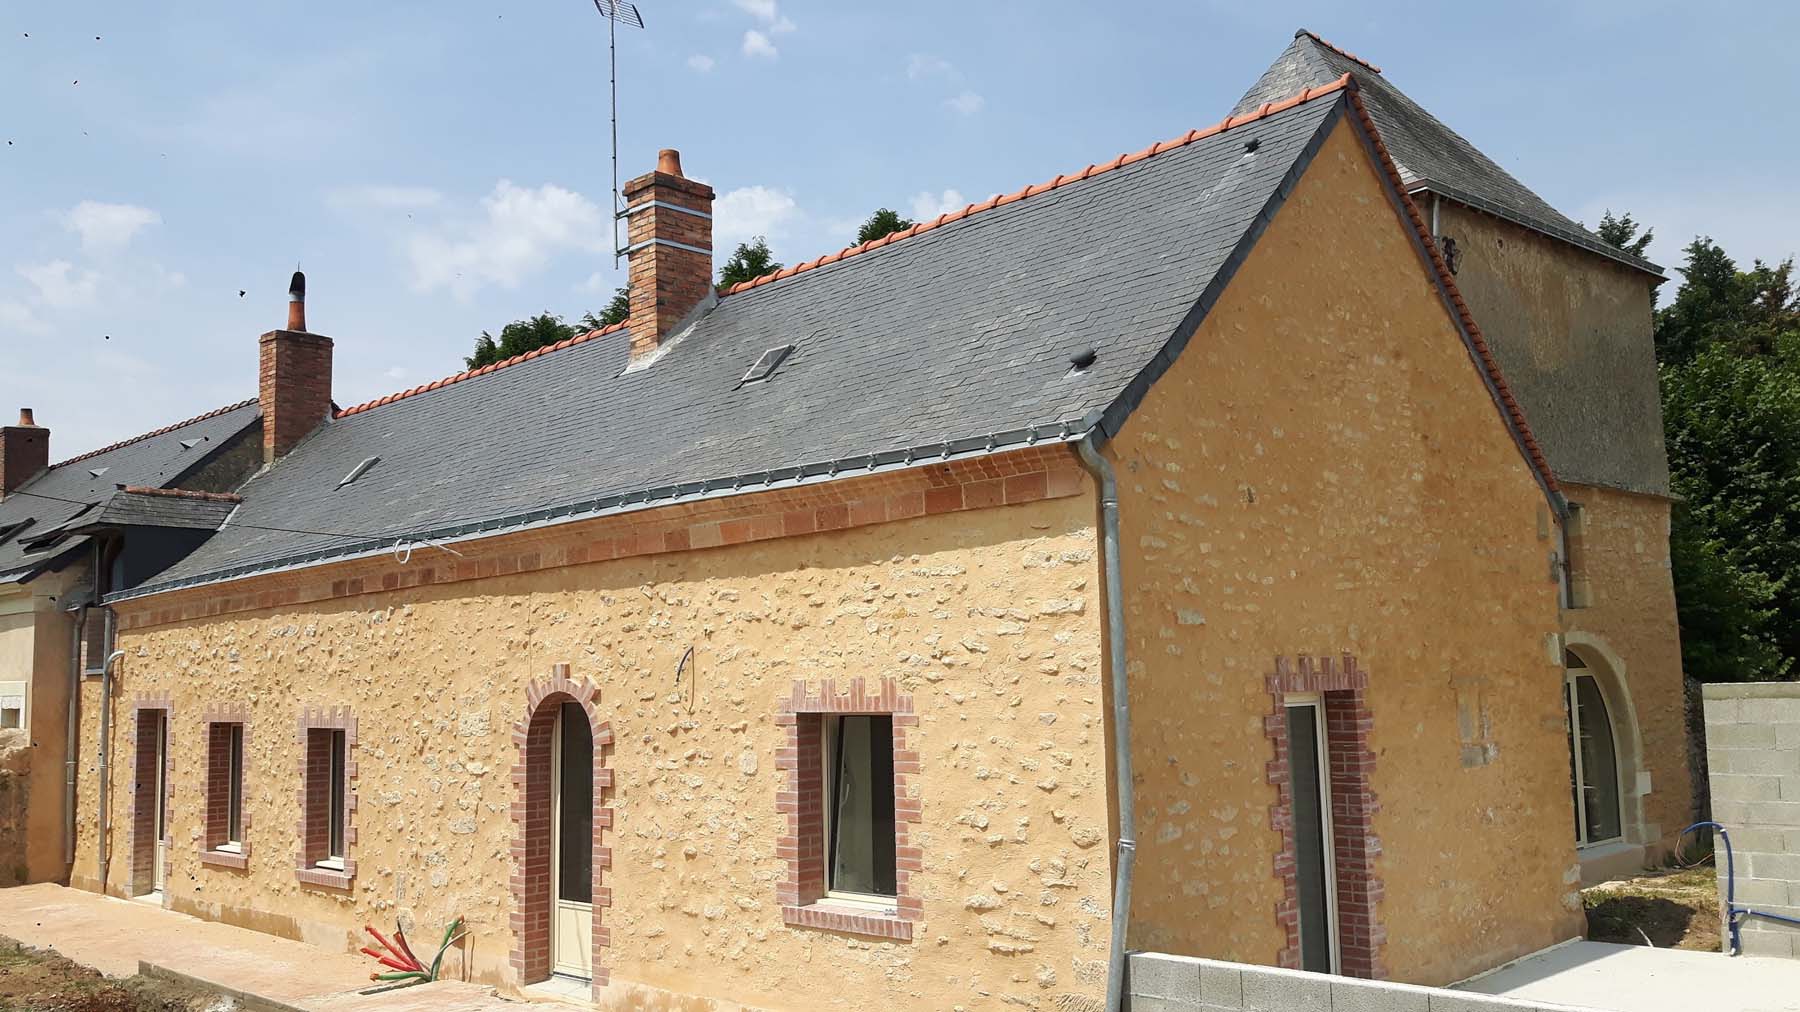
[776, 677, 925, 942]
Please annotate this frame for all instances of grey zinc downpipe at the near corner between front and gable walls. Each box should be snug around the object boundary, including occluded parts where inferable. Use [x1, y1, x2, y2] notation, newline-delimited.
[1075, 432, 1138, 1012]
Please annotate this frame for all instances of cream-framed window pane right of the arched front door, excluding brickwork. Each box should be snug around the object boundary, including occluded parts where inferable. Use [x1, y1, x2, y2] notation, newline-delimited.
[823, 713, 896, 902]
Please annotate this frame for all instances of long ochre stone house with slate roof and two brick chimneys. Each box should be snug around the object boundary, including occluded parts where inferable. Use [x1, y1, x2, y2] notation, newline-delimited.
[56, 68, 1648, 1008]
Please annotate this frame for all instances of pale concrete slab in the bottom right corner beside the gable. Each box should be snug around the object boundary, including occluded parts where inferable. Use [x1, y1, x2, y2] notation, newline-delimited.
[1456, 942, 1800, 1012]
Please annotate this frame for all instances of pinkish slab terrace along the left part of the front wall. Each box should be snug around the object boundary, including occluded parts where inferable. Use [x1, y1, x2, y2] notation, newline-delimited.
[0, 884, 520, 1012]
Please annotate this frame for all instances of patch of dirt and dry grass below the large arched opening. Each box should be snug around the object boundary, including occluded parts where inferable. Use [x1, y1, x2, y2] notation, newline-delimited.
[1582, 864, 1719, 953]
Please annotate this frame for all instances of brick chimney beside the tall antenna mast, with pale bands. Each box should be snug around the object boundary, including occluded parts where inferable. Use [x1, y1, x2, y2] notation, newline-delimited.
[625, 148, 713, 360]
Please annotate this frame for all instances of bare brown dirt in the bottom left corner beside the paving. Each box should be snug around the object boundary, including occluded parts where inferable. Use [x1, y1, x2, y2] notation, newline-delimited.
[0, 935, 221, 1012]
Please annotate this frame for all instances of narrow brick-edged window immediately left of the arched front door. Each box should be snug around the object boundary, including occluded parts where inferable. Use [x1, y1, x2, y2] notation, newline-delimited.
[293, 706, 356, 890]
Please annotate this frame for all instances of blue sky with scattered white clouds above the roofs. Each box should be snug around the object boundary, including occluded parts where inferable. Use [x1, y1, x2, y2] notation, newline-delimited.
[0, 0, 1800, 459]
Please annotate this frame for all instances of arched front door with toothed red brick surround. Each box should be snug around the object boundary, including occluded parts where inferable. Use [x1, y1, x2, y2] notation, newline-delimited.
[513, 664, 612, 992]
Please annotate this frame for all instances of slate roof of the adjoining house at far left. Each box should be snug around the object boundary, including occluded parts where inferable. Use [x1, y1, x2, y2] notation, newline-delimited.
[0, 400, 263, 583]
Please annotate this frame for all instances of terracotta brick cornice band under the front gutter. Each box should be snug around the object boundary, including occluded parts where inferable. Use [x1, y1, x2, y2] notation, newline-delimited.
[130, 443, 1085, 632]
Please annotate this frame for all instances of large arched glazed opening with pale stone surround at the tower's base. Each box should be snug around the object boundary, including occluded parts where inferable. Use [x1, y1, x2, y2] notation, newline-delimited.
[1562, 634, 1652, 884]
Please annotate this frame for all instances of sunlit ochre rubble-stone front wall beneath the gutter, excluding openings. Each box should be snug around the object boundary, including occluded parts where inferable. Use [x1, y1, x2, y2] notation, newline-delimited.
[77, 486, 1111, 1008]
